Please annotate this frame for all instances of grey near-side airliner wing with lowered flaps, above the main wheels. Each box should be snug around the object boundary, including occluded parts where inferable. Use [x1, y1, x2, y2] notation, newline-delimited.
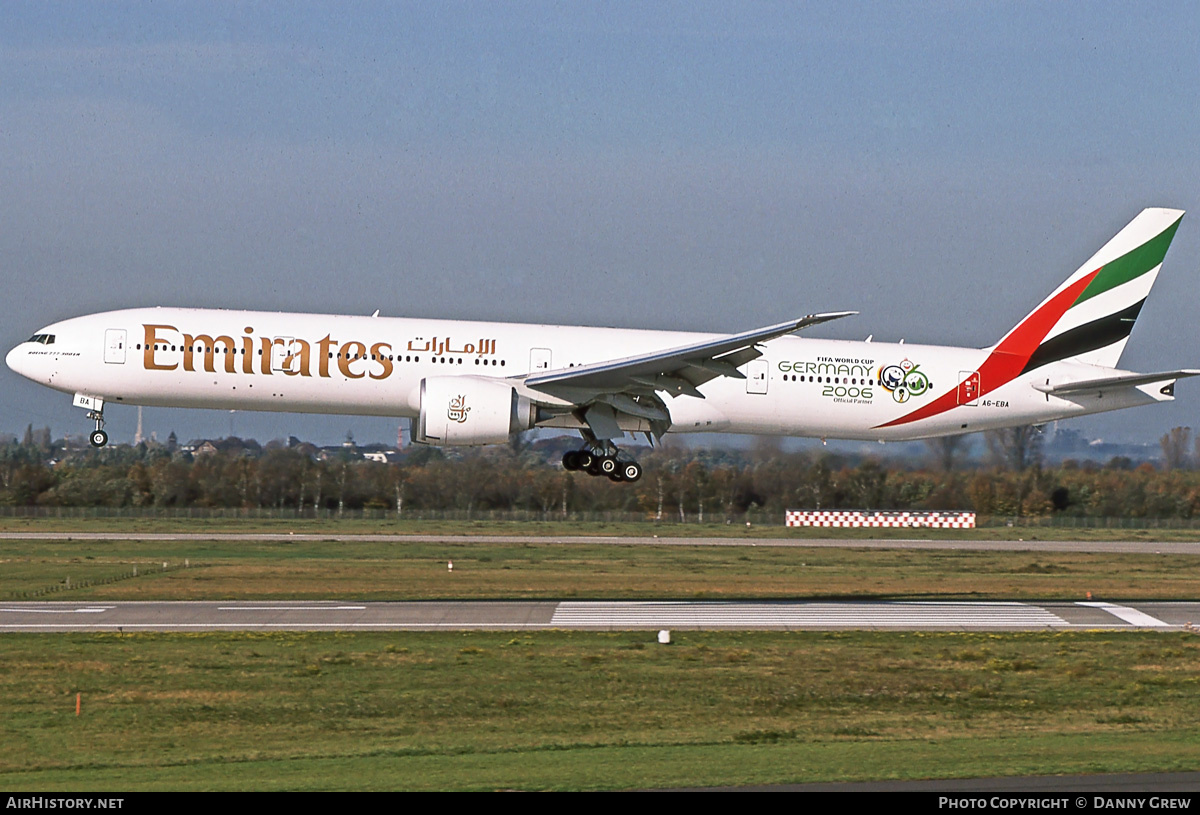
[522, 311, 858, 438]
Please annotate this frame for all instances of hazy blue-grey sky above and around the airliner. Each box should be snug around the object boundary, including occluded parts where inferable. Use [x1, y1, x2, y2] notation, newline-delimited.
[0, 2, 1200, 441]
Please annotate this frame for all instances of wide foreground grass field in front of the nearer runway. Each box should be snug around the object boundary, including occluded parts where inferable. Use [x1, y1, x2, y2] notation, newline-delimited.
[0, 631, 1200, 790]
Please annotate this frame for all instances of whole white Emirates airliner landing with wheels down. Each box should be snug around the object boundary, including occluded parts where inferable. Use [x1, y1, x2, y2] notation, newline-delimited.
[7, 209, 1200, 481]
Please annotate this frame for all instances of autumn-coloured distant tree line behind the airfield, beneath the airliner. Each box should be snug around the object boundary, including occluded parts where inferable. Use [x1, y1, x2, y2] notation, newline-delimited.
[7, 429, 1200, 522]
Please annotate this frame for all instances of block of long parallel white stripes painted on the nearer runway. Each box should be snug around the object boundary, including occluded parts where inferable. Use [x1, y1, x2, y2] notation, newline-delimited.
[551, 600, 1069, 628]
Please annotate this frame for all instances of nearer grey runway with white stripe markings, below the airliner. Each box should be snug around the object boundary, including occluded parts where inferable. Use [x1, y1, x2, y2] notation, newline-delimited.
[0, 600, 1200, 633]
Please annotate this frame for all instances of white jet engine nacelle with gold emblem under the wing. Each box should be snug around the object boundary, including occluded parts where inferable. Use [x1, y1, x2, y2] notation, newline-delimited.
[413, 377, 535, 447]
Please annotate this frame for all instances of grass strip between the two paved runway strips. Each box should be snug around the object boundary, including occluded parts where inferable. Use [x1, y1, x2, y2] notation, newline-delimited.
[7, 540, 1200, 600]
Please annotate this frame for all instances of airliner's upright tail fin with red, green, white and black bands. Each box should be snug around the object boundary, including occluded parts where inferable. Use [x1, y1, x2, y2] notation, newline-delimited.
[994, 209, 1183, 373]
